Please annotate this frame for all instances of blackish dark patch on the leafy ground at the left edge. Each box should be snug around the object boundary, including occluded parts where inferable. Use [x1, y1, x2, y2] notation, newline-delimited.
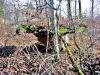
[0, 46, 16, 57]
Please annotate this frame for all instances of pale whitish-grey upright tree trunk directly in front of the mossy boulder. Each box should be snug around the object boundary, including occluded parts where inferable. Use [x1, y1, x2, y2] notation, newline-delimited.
[50, 0, 60, 62]
